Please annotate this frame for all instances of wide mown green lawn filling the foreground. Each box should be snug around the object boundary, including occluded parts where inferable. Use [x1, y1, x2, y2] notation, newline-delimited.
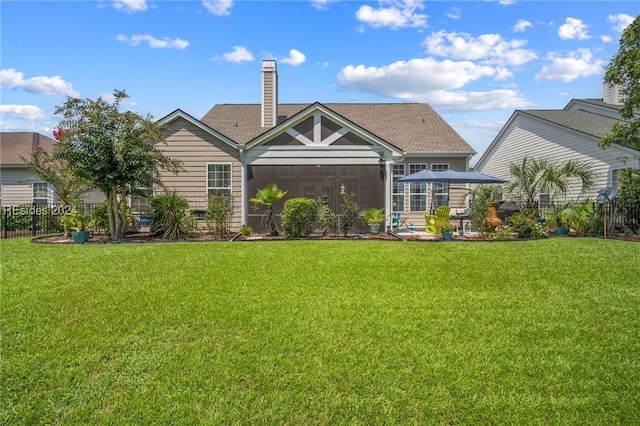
[0, 238, 640, 425]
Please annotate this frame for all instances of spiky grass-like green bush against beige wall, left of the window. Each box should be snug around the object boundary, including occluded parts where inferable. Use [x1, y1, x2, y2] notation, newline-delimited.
[151, 191, 197, 240]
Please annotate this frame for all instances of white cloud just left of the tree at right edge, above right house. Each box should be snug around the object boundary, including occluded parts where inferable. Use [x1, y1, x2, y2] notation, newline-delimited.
[534, 49, 605, 83]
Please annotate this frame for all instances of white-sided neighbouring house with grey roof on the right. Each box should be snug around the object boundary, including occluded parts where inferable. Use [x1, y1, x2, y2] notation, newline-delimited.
[475, 86, 640, 203]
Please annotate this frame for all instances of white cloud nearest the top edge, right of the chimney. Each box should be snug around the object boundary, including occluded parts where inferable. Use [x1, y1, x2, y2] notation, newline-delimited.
[356, 0, 427, 29]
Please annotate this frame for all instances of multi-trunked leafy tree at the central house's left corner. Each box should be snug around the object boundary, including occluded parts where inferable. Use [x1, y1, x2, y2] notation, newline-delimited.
[54, 90, 181, 241]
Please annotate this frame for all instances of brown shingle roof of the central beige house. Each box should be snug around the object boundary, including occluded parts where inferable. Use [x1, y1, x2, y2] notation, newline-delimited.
[201, 103, 475, 154]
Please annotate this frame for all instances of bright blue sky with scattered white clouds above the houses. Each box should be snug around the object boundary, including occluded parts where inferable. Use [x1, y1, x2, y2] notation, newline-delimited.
[0, 0, 640, 159]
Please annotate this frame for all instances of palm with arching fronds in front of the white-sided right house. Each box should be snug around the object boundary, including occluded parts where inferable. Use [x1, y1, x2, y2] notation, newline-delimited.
[505, 157, 595, 211]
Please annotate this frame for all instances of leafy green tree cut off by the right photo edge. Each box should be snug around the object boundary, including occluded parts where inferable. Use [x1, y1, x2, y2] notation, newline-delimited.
[600, 16, 640, 150]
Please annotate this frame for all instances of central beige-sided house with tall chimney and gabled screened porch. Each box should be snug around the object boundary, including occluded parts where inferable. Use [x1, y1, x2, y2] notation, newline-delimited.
[158, 60, 475, 230]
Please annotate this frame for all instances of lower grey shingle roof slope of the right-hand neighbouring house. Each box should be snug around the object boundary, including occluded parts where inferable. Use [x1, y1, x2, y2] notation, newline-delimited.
[519, 110, 620, 139]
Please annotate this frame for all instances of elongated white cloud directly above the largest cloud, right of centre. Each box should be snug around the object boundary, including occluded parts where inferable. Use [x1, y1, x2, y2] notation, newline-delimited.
[424, 30, 537, 66]
